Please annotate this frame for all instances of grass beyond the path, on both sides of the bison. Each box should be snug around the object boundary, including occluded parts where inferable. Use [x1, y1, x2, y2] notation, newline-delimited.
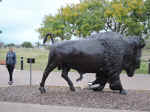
[0, 48, 150, 74]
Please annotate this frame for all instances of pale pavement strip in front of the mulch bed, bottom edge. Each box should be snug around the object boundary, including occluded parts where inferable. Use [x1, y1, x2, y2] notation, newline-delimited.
[0, 102, 147, 112]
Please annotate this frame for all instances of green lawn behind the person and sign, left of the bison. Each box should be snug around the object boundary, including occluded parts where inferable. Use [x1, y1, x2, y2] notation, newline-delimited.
[0, 48, 49, 70]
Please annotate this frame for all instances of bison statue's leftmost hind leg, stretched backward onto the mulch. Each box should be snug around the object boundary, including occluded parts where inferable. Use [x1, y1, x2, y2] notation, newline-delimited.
[39, 64, 56, 94]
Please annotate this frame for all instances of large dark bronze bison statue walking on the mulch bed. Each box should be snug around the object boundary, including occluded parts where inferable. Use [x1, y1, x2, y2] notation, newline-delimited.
[39, 32, 145, 94]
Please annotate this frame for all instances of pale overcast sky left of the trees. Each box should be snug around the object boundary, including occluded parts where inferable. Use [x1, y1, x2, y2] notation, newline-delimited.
[0, 0, 79, 44]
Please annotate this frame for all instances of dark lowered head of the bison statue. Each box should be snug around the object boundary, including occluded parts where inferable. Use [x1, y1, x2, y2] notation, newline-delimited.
[124, 37, 145, 77]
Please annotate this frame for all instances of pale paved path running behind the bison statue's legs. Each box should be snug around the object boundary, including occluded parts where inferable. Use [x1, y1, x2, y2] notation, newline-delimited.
[0, 65, 150, 90]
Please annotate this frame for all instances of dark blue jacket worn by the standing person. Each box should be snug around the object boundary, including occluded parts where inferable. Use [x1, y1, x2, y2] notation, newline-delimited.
[6, 51, 16, 65]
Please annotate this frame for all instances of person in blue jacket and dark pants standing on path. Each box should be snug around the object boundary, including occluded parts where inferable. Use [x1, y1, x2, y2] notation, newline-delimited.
[6, 47, 16, 85]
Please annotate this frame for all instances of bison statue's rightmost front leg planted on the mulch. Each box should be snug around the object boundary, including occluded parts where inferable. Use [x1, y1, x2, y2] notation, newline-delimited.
[109, 76, 127, 95]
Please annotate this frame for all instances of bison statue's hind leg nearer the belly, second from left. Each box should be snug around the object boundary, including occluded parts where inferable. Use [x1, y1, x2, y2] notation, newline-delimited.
[61, 68, 75, 91]
